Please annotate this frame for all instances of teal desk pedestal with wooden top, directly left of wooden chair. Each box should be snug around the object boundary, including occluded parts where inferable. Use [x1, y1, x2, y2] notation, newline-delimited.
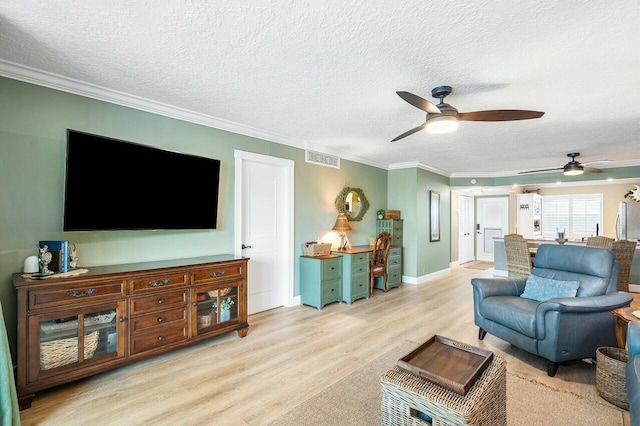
[331, 246, 373, 304]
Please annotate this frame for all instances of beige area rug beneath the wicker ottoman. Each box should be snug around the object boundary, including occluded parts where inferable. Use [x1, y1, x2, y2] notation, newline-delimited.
[272, 342, 623, 426]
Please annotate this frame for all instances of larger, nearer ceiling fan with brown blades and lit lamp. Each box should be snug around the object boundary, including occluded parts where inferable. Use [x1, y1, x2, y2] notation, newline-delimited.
[391, 86, 544, 142]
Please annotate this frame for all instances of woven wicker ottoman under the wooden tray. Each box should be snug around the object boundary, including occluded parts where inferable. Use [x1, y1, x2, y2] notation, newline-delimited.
[380, 354, 507, 426]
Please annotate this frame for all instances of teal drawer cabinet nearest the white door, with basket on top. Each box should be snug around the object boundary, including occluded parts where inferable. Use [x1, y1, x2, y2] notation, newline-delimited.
[300, 254, 342, 309]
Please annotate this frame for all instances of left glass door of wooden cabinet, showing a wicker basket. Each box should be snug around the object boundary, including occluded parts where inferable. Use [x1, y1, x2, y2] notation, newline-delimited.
[29, 301, 125, 376]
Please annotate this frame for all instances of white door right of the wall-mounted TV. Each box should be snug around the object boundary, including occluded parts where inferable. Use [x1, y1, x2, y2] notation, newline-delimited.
[235, 151, 294, 314]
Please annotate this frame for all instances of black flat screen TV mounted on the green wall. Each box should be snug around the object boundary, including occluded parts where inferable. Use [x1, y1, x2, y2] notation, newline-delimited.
[63, 129, 220, 231]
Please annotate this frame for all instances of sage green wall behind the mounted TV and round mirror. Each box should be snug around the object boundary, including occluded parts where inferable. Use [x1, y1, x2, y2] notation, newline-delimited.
[0, 78, 387, 356]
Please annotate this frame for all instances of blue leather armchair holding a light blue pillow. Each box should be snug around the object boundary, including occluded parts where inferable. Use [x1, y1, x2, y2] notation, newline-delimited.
[471, 244, 633, 377]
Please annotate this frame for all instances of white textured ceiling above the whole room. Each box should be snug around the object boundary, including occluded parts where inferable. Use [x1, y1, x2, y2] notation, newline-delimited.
[0, 0, 640, 176]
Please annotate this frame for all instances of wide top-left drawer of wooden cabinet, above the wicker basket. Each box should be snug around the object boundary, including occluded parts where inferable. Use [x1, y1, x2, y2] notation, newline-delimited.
[29, 280, 126, 309]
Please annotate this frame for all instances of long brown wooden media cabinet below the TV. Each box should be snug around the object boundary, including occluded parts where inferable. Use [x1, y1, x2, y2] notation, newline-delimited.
[13, 255, 249, 409]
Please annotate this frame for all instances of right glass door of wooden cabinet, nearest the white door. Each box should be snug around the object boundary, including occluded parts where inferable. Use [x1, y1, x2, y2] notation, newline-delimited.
[192, 283, 239, 334]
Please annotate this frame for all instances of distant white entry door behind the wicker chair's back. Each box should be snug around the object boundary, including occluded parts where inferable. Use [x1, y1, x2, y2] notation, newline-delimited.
[476, 197, 509, 262]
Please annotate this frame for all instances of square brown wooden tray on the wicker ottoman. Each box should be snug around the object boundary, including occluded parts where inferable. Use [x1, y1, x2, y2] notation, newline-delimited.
[398, 335, 493, 395]
